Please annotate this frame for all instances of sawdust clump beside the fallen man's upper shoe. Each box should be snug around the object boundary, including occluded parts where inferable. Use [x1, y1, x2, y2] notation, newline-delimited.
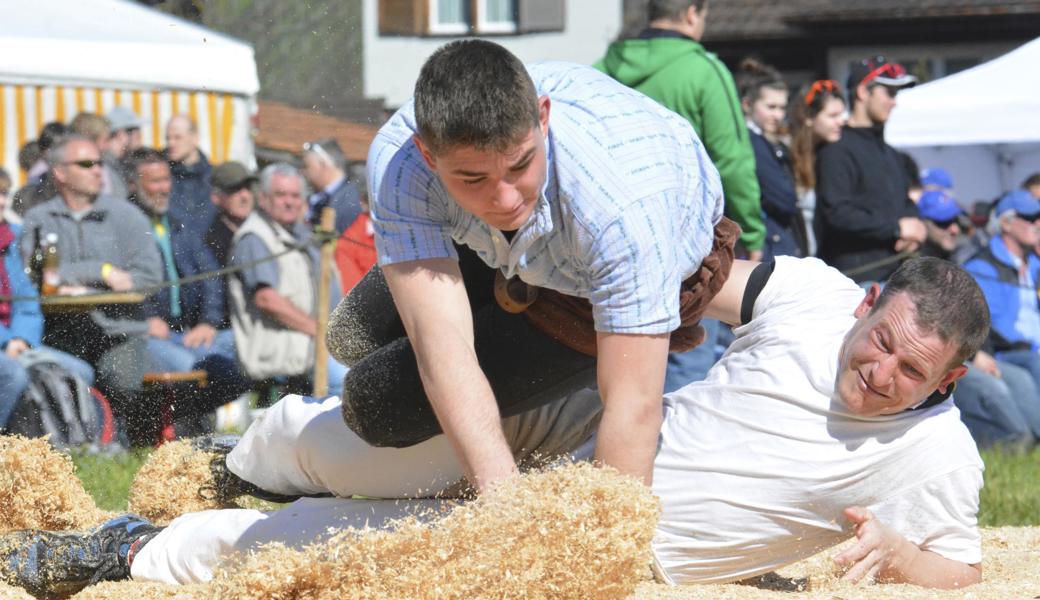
[128, 440, 229, 525]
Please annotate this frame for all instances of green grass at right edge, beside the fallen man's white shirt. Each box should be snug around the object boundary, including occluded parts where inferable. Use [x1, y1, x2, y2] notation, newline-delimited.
[979, 449, 1040, 527]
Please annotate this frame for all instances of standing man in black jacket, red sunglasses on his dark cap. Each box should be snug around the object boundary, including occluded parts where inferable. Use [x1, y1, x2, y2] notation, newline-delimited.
[814, 56, 927, 285]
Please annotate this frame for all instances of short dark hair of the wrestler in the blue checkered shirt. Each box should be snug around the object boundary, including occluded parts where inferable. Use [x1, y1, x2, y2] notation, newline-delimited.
[415, 40, 539, 154]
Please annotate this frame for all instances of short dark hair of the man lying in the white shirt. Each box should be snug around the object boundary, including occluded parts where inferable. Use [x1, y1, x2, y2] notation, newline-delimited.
[873, 257, 989, 368]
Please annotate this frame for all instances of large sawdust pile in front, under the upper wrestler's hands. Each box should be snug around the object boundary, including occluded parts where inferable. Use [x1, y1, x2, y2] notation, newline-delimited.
[204, 465, 658, 600]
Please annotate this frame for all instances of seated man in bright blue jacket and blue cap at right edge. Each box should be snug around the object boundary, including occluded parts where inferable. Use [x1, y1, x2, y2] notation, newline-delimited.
[964, 189, 1040, 420]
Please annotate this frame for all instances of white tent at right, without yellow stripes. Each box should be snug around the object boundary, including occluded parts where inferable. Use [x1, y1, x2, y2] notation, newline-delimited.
[885, 38, 1040, 204]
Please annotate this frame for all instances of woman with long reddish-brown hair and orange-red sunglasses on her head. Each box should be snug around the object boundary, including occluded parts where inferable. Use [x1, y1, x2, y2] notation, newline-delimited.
[790, 79, 847, 256]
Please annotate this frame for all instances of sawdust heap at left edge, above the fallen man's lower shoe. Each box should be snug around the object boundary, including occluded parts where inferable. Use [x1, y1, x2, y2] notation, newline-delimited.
[0, 436, 110, 533]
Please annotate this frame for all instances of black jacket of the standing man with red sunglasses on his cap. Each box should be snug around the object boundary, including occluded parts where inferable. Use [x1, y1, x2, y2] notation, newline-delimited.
[813, 127, 918, 282]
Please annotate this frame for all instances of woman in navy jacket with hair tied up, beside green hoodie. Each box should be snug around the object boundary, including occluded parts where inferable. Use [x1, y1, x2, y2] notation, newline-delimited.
[736, 58, 807, 260]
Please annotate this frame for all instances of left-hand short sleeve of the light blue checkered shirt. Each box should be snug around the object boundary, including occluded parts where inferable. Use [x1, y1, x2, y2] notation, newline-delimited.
[368, 107, 458, 265]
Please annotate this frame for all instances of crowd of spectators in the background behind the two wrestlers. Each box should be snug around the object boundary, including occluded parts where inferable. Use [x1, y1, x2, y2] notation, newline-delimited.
[0, 0, 1040, 447]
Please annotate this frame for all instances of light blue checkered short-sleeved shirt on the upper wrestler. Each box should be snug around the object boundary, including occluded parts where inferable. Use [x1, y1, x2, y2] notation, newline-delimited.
[368, 62, 723, 335]
